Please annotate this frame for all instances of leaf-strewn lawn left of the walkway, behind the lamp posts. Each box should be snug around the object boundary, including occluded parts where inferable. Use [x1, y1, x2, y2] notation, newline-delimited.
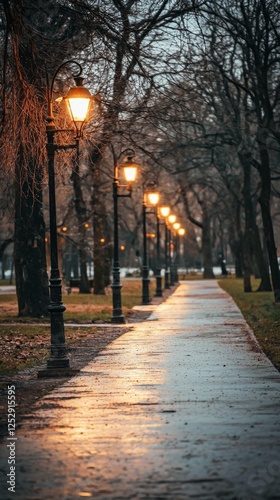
[0, 280, 155, 375]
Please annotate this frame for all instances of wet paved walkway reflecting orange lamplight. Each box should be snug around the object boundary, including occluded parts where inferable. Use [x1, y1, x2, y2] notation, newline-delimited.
[0, 280, 280, 500]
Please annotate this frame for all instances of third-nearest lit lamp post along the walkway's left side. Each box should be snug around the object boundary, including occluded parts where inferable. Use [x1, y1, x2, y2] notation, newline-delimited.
[142, 183, 159, 305]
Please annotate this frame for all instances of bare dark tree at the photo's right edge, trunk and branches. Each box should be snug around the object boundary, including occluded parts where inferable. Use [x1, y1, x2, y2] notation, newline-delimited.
[199, 0, 280, 296]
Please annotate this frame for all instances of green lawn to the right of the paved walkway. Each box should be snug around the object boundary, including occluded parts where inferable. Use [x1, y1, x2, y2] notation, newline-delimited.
[219, 277, 280, 370]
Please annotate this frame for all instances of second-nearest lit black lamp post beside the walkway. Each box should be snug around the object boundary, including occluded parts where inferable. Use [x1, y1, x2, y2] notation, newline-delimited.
[111, 149, 137, 323]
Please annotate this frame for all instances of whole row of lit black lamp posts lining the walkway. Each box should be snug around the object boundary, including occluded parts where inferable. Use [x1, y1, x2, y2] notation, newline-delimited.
[38, 60, 184, 377]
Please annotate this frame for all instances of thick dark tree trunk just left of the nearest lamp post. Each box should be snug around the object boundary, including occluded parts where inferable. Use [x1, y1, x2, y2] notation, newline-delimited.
[14, 158, 49, 317]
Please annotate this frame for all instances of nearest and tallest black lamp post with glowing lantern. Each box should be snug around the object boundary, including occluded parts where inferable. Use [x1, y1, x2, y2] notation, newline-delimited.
[38, 60, 92, 377]
